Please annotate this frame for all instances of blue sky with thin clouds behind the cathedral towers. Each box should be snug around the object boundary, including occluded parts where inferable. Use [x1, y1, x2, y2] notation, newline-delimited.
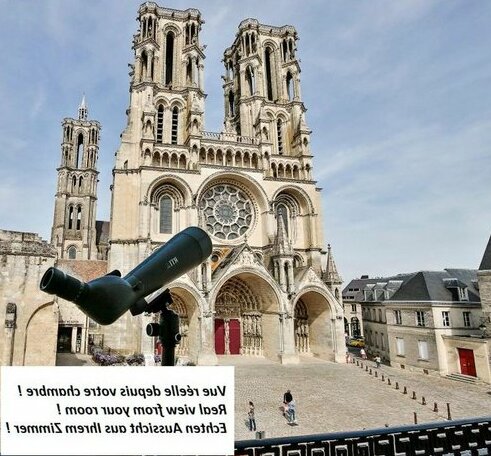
[0, 0, 491, 282]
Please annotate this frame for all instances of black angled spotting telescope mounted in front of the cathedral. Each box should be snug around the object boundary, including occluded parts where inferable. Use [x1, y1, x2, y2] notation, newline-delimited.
[40, 226, 212, 325]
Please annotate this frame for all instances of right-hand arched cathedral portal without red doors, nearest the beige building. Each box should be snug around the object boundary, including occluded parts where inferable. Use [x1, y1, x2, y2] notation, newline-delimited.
[294, 291, 336, 360]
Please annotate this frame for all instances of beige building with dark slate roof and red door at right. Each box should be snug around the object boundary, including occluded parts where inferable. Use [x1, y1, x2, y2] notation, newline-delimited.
[343, 269, 491, 382]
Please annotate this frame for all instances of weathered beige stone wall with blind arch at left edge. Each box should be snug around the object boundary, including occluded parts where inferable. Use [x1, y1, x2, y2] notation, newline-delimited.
[0, 230, 58, 366]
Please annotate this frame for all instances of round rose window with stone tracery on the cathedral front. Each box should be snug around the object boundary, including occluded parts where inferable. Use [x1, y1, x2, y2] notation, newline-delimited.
[200, 184, 254, 241]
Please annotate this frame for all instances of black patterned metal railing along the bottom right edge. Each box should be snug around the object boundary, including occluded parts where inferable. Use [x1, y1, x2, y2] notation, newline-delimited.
[235, 416, 491, 456]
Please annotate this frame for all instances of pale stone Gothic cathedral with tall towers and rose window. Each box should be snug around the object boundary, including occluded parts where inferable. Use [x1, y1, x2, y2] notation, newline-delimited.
[52, 2, 345, 364]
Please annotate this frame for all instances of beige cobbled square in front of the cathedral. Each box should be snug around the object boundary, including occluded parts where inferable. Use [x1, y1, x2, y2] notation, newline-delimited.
[226, 357, 491, 440]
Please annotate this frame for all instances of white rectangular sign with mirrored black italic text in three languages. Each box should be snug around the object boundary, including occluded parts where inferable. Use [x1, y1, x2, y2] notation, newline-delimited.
[0, 366, 234, 456]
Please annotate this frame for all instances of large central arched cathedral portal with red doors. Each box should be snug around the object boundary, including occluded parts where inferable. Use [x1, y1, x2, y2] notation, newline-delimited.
[215, 273, 279, 357]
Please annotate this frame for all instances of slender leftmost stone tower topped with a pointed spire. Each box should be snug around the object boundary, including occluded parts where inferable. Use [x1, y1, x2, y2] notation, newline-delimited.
[51, 95, 101, 260]
